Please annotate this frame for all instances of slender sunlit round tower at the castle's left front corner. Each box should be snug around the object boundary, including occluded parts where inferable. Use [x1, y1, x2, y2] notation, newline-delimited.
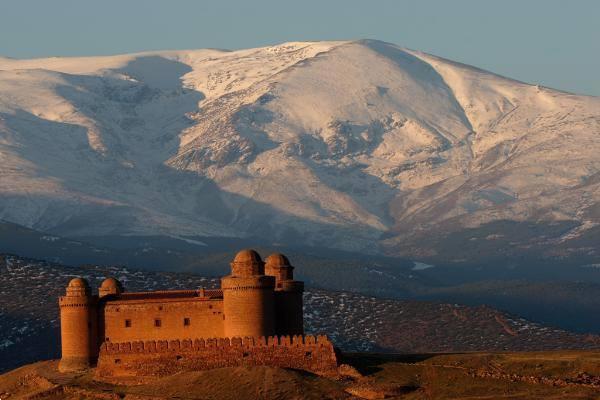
[58, 278, 98, 372]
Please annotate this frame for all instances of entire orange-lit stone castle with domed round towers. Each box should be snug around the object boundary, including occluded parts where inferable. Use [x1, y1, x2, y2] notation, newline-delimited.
[59, 250, 337, 377]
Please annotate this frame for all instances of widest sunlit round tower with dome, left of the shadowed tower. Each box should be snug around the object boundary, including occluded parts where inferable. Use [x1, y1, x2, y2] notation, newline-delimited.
[221, 250, 275, 337]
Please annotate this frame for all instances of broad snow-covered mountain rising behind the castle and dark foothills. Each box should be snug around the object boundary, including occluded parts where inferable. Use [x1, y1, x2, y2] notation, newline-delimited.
[0, 40, 600, 258]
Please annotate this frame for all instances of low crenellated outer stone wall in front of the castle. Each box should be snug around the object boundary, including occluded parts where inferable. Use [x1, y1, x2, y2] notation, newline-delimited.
[96, 335, 338, 377]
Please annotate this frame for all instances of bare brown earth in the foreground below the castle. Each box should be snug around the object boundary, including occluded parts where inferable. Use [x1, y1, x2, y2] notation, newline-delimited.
[0, 351, 600, 400]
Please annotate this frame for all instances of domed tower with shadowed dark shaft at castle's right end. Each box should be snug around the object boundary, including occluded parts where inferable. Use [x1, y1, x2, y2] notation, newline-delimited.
[265, 253, 304, 335]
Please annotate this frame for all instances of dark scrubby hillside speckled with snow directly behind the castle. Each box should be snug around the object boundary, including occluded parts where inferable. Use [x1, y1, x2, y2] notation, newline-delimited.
[0, 255, 600, 371]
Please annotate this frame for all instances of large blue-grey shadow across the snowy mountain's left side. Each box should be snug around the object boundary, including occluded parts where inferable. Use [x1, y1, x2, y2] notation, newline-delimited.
[0, 56, 384, 248]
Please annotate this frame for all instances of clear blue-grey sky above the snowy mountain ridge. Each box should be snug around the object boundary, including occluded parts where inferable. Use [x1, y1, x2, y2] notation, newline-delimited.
[0, 0, 600, 96]
